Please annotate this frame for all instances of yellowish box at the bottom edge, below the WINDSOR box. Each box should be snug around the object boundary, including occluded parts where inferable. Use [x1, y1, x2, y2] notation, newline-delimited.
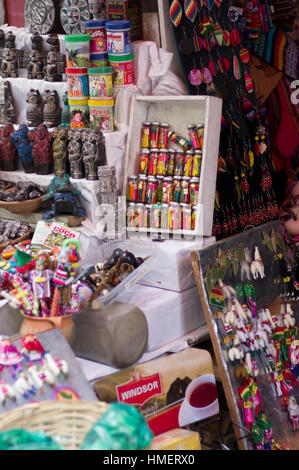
[149, 428, 201, 450]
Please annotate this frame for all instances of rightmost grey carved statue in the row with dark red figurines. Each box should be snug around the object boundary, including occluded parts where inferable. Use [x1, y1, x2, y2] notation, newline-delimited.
[82, 130, 103, 180]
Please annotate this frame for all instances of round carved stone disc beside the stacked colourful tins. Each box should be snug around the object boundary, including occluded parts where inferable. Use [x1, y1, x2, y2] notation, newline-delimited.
[60, 0, 90, 34]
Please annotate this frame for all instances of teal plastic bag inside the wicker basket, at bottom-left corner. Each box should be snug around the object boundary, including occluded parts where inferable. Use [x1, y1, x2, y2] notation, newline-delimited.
[0, 429, 63, 450]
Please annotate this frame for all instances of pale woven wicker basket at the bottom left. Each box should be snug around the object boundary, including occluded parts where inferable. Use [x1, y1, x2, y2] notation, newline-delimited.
[0, 401, 109, 450]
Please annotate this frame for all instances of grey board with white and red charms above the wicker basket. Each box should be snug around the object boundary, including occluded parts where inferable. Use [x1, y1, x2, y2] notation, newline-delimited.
[0, 329, 97, 413]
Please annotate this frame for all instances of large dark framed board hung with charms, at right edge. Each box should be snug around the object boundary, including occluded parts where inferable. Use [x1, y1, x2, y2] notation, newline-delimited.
[191, 221, 299, 450]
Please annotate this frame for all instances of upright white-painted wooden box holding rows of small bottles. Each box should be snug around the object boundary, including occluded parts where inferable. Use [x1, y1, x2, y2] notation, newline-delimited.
[123, 96, 222, 237]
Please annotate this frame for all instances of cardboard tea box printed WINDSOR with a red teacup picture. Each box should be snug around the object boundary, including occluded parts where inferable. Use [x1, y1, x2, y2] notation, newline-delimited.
[94, 348, 219, 435]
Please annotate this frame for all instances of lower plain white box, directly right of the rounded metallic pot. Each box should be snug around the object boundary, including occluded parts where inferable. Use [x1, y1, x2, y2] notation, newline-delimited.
[117, 285, 206, 352]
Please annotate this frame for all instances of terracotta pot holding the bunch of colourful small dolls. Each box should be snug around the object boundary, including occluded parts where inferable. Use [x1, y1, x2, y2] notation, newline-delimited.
[20, 315, 76, 344]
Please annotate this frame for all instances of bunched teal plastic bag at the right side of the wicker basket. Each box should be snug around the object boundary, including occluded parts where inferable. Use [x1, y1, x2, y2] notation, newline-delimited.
[81, 403, 153, 450]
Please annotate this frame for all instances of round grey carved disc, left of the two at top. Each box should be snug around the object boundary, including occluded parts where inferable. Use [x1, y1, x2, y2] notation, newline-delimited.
[24, 0, 55, 35]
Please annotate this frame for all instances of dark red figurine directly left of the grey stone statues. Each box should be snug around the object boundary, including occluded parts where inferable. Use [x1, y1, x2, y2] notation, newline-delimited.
[28, 124, 53, 175]
